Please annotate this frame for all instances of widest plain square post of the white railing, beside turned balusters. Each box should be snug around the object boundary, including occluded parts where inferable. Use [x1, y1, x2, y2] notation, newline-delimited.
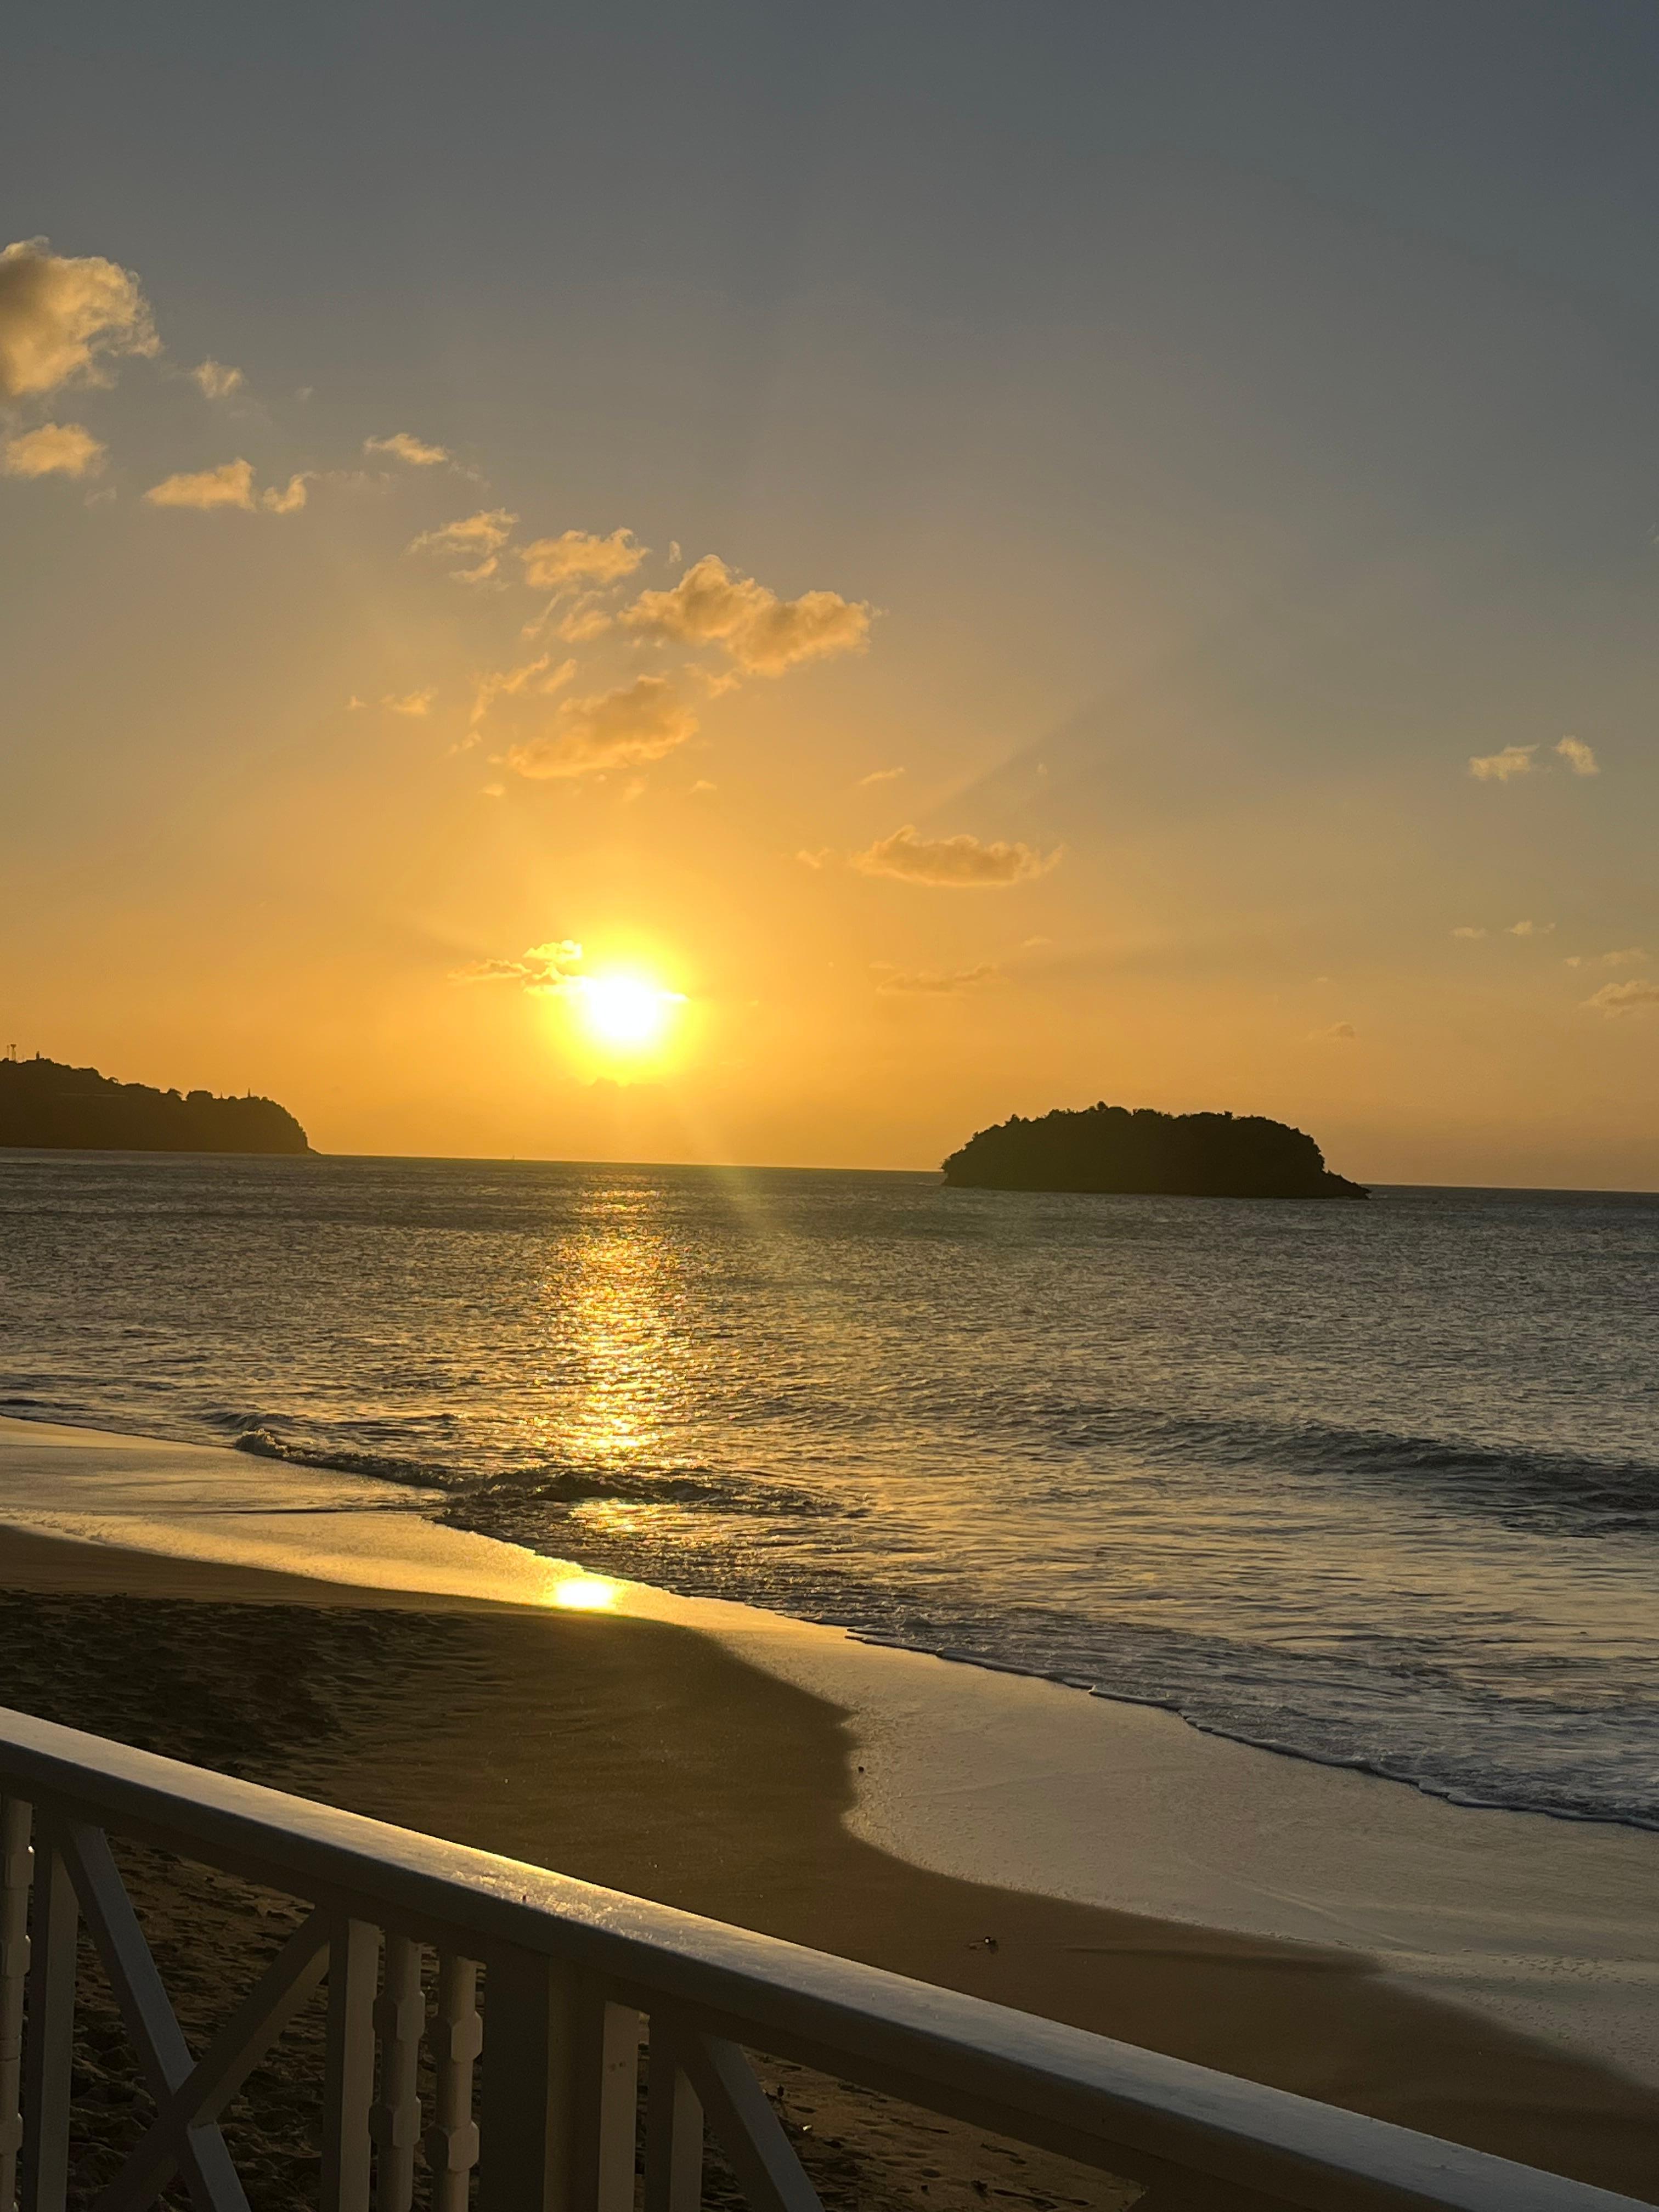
[478, 1949, 591, 2212]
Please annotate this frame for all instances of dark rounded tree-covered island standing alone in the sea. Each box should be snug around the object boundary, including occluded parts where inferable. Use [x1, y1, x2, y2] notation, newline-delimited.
[945, 1104, 1372, 1199]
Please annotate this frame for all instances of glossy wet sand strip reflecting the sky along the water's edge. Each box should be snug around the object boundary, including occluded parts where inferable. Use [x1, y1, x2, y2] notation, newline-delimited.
[0, 1418, 1659, 2084]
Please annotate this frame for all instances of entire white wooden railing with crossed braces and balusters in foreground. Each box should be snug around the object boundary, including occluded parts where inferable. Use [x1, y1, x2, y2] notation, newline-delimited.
[0, 1712, 1635, 2212]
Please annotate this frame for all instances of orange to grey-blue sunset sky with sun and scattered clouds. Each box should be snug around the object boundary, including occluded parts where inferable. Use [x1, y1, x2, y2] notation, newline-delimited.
[0, 0, 1659, 1188]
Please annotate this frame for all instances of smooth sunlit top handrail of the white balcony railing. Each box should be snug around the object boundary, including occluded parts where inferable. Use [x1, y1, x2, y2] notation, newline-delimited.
[0, 1708, 1637, 2212]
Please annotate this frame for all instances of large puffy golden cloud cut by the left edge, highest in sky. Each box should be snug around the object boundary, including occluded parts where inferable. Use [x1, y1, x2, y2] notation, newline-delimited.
[0, 239, 161, 400]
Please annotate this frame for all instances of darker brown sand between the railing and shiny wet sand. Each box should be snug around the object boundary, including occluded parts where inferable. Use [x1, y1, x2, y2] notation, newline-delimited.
[0, 1477, 1659, 2203]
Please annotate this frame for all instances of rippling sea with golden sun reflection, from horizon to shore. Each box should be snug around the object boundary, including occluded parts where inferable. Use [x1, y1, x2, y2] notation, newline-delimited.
[0, 1153, 1659, 1827]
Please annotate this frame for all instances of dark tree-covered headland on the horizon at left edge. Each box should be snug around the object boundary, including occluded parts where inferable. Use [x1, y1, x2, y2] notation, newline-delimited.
[0, 1053, 309, 1153]
